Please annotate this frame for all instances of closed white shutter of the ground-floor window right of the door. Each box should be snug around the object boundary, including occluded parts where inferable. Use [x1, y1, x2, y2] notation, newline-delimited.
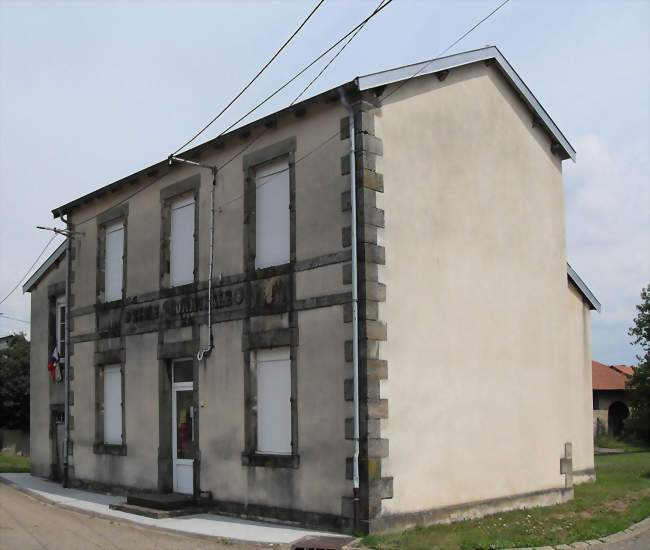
[257, 348, 291, 455]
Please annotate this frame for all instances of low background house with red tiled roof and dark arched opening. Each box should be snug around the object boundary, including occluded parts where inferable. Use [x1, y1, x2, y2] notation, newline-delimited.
[591, 361, 634, 437]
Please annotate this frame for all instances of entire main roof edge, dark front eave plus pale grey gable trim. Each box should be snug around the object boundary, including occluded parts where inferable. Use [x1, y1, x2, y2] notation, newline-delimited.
[52, 46, 576, 218]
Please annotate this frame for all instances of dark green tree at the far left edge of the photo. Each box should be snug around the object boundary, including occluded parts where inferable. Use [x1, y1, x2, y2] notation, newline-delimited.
[0, 334, 29, 430]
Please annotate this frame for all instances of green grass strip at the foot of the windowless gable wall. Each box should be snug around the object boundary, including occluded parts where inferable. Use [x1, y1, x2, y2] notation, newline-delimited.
[362, 452, 650, 550]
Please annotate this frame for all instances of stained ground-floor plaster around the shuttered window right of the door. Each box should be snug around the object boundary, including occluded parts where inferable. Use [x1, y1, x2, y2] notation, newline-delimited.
[199, 306, 352, 515]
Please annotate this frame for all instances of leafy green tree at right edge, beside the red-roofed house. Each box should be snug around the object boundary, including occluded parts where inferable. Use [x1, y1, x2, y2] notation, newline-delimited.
[625, 284, 650, 443]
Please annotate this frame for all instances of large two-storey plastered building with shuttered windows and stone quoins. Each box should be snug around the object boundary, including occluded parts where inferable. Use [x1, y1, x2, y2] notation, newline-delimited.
[25, 47, 599, 532]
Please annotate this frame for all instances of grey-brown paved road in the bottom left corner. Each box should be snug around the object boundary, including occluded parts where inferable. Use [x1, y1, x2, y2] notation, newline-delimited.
[0, 484, 269, 550]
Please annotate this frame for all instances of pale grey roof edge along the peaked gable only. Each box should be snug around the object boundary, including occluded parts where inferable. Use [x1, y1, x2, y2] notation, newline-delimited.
[356, 46, 576, 162]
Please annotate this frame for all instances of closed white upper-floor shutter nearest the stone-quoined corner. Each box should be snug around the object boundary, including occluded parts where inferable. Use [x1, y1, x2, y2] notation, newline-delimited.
[255, 159, 290, 269]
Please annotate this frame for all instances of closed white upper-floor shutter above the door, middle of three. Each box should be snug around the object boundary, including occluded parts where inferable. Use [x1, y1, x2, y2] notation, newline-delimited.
[169, 197, 194, 286]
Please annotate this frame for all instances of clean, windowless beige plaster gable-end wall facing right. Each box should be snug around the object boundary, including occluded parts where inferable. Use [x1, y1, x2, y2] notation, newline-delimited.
[375, 63, 575, 514]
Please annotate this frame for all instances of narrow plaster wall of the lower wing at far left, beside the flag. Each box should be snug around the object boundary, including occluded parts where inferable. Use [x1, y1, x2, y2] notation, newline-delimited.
[29, 253, 65, 476]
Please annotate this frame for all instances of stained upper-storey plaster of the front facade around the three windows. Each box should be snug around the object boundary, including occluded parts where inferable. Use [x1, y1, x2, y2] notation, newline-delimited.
[65, 104, 350, 314]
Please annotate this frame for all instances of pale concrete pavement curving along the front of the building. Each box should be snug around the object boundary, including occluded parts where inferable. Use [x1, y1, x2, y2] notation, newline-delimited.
[0, 473, 350, 548]
